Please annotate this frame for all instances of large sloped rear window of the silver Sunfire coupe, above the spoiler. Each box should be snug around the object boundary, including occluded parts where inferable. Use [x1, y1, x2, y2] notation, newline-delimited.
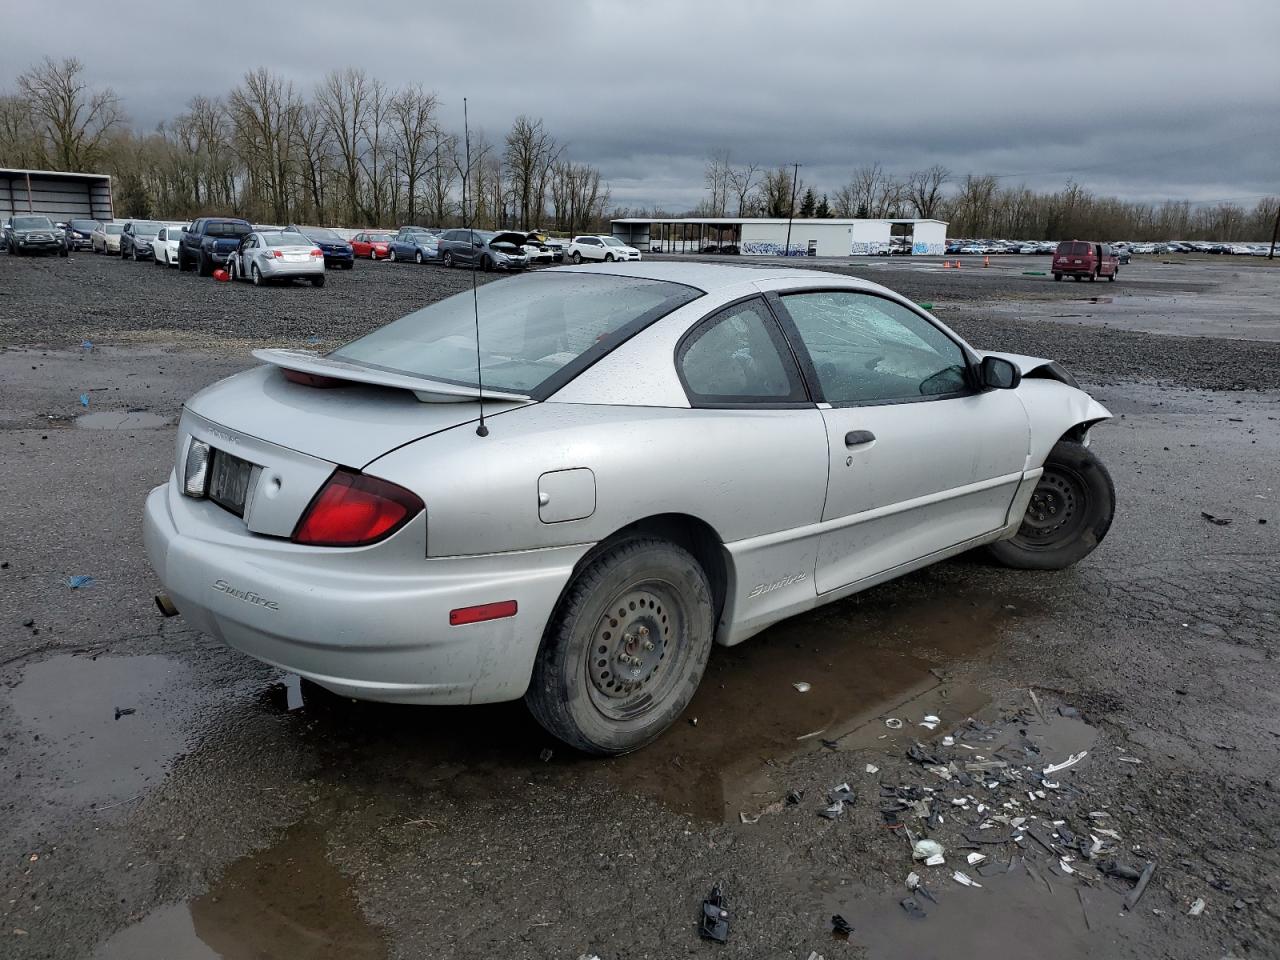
[330, 273, 701, 393]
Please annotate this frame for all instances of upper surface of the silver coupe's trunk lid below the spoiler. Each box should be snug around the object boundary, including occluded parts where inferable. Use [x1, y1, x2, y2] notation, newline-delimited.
[186, 365, 525, 468]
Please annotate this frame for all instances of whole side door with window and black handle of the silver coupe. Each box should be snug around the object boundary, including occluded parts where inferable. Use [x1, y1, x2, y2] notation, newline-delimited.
[771, 288, 1030, 594]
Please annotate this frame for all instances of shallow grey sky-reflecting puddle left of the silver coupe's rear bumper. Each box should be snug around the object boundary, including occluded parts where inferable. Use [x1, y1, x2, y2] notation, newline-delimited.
[8, 655, 188, 809]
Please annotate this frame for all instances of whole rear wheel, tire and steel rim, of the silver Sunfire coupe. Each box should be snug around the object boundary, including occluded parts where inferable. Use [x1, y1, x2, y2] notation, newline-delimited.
[525, 538, 716, 756]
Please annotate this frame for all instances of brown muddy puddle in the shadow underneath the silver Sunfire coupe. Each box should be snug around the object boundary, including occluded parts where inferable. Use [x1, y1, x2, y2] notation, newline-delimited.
[280, 576, 1034, 820]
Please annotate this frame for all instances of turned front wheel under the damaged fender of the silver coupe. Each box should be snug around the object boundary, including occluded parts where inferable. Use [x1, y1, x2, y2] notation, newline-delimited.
[987, 440, 1116, 570]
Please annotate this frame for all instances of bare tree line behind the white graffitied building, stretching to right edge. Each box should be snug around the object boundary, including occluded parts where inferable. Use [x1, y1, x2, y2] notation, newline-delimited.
[670, 150, 1280, 241]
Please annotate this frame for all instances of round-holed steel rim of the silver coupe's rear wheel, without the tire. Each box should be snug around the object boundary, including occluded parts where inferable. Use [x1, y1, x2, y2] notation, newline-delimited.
[586, 580, 687, 721]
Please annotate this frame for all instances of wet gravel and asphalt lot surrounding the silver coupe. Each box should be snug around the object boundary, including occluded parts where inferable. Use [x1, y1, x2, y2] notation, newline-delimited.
[0, 255, 1280, 960]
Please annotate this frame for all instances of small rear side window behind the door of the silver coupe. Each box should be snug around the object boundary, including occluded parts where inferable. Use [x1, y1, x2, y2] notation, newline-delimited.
[676, 300, 805, 406]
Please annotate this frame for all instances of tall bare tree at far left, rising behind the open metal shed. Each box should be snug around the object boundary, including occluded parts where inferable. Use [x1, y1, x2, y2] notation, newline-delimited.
[18, 56, 124, 170]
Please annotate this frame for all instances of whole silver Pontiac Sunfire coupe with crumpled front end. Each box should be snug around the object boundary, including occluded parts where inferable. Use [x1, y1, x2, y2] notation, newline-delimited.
[145, 262, 1115, 754]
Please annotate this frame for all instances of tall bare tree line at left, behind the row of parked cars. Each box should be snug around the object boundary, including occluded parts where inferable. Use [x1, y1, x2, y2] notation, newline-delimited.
[0, 58, 609, 234]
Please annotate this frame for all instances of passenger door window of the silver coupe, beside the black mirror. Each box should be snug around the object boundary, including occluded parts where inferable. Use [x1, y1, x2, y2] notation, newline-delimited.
[782, 291, 968, 404]
